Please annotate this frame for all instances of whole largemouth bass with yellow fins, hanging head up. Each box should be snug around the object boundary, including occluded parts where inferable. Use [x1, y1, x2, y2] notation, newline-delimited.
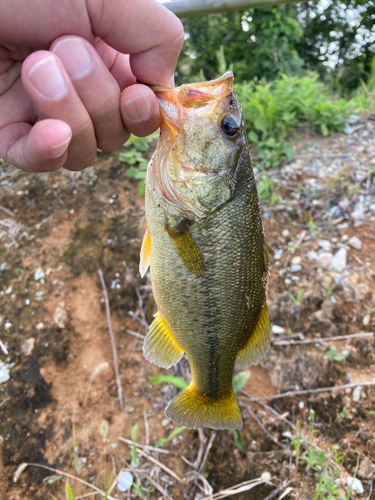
[140, 72, 271, 429]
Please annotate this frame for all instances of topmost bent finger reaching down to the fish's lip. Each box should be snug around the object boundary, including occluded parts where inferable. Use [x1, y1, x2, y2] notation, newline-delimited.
[87, 0, 184, 87]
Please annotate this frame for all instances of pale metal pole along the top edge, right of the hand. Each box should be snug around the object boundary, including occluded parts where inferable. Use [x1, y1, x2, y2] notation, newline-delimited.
[161, 0, 300, 17]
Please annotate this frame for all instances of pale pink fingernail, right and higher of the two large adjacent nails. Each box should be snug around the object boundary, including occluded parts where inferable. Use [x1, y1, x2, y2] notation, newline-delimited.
[52, 38, 92, 78]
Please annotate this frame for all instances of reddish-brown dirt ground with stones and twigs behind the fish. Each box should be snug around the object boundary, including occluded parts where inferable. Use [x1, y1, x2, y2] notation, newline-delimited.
[0, 119, 375, 500]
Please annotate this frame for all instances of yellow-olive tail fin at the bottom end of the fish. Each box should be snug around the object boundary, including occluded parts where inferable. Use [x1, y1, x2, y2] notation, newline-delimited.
[165, 383, 243, 429]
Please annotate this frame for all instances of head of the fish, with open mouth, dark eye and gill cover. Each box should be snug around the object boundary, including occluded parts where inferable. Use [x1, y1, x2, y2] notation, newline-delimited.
[149, 72, 246, 220]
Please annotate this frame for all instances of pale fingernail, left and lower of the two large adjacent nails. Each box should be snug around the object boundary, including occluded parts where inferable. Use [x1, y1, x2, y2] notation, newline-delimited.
[29, 56, 66, 99]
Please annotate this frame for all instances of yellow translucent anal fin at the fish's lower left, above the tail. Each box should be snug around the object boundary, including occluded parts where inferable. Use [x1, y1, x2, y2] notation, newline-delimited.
[143, 312, 184, 368]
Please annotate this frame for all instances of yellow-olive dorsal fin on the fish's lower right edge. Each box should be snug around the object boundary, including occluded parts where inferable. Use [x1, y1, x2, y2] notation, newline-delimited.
[235, 299, 271, 369]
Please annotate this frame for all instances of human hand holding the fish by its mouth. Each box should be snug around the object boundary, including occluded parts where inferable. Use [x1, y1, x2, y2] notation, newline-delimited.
[0, 0, 184, 172]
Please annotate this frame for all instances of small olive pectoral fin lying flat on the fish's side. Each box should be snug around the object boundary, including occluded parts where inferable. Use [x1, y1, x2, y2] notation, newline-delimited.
[166, 221, 204, 276]
